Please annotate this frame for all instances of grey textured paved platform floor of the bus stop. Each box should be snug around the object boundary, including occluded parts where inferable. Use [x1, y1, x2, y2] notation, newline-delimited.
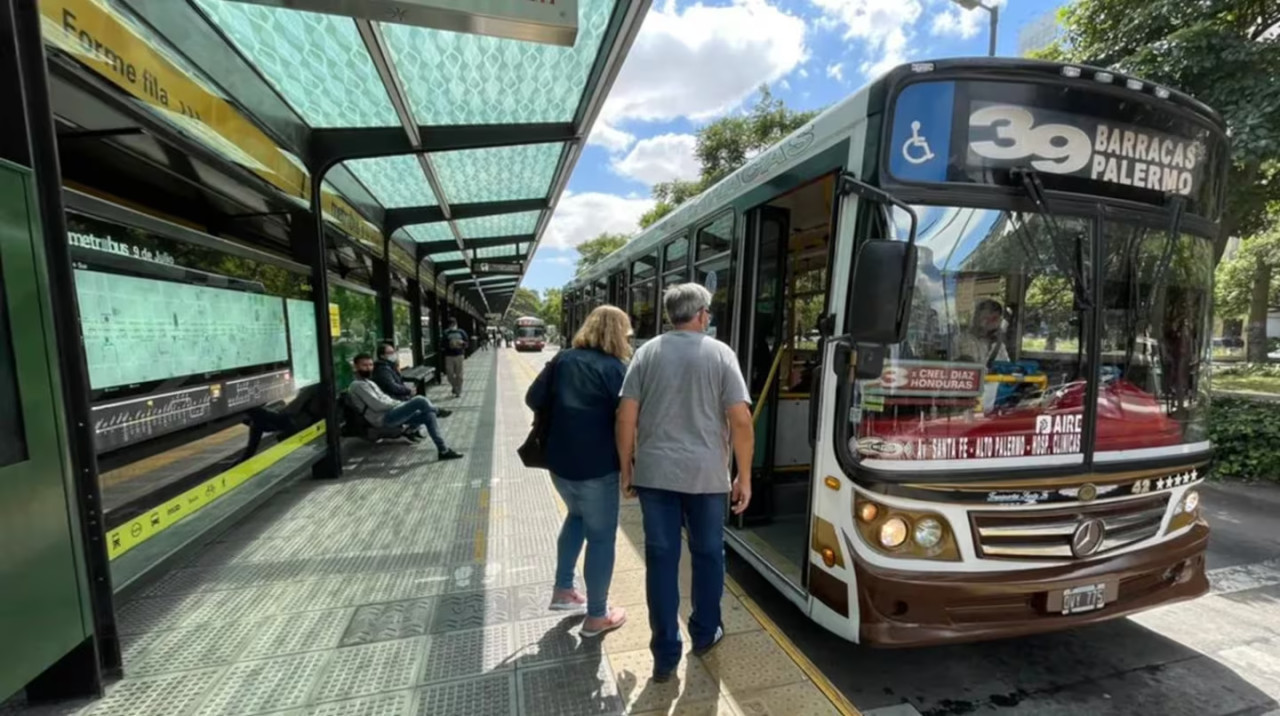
[10, 350, 852, 716]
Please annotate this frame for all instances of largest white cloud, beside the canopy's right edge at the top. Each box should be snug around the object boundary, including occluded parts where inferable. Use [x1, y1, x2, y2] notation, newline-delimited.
[598, 0, 808, 143]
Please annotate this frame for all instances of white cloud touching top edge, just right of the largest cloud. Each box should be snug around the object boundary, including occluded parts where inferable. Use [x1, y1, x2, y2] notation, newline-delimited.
[809, 0, 924, 77]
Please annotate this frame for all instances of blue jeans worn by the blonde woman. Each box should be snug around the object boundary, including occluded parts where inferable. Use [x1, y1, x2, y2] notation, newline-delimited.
[552, 473, 621, 619]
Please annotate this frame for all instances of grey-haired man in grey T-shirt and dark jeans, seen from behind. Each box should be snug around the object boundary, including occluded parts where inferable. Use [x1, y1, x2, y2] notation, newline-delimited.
[617, 283, 755, 683]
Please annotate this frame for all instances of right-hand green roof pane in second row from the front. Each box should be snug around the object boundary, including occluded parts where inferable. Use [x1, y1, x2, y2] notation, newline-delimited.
[431, 142, 564, 204]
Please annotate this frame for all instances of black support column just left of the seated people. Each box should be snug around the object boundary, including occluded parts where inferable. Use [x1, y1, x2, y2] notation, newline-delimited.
[289, 210, 342, 479]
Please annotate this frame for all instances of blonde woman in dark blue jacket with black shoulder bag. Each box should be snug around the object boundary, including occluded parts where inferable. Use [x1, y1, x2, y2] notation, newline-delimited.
[525, 306, 631, 637]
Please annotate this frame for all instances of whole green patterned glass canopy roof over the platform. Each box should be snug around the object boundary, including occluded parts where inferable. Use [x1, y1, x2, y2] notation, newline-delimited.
[167, 0, 637, 311]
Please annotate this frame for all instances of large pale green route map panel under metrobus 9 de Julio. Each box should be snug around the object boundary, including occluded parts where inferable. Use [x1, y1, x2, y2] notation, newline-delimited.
[76, 269, 288, 391]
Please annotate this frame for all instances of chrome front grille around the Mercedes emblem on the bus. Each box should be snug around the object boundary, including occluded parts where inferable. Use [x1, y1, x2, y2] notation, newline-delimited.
[970, 493, 1169, 560]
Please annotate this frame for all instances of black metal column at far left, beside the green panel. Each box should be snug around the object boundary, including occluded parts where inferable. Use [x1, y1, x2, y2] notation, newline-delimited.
[0, 0, 123, 701]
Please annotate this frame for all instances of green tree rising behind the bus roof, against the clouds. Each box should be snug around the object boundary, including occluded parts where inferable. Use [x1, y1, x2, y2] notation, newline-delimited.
[640, 85, 819, 228]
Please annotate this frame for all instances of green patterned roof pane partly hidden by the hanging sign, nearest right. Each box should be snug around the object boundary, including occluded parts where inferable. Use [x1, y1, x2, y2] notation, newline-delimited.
[383, 0, 614, 124]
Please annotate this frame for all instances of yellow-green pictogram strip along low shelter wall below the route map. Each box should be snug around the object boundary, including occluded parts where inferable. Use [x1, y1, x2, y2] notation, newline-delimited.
[106, 420, 324, 560]
